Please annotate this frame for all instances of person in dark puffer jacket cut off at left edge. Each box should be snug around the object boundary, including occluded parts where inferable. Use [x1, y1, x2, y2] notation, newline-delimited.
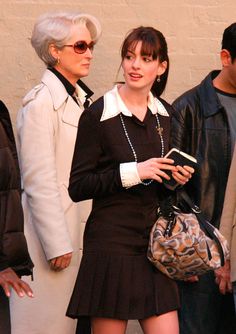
[0, 101, 33, 334]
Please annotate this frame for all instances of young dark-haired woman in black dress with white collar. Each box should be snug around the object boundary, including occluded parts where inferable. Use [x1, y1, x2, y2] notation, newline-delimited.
[67, 27, 193, 334]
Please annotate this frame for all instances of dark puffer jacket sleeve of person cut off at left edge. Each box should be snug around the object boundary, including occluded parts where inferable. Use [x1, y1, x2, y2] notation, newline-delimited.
[0, 101, 33, 276]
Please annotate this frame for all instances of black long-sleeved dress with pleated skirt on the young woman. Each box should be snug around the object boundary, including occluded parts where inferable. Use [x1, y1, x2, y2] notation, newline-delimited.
[67, 90, 179, 319]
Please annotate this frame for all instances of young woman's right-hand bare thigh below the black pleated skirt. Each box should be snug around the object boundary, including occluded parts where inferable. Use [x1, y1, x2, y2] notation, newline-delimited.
[139, 311, 179, 334]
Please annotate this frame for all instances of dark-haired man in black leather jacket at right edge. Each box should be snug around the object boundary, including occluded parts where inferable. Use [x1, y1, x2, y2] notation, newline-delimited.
[171, 23, 236, 334]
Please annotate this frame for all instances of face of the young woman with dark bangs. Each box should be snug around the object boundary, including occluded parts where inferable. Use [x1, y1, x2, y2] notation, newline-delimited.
[122, 41, 167, 91]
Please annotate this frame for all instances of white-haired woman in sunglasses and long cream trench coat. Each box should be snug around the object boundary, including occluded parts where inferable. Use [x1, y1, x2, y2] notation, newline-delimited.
[11, 13, 101, 334]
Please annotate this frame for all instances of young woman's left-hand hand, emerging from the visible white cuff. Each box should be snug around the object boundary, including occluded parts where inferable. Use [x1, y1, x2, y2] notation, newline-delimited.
[137, 158, 178, 183]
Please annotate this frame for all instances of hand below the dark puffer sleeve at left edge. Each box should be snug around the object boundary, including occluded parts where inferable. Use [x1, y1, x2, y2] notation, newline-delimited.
[0, 268, 33, 297]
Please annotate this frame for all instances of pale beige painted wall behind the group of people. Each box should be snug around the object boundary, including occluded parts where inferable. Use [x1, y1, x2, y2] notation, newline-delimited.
[0, 0, 236, 334]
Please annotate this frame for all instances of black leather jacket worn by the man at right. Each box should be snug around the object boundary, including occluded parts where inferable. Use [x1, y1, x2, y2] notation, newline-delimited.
[171, 71, 231, 227]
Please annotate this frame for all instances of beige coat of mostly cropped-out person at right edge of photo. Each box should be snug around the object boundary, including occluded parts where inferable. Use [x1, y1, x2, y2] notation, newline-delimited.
[220, 145, 236, 282]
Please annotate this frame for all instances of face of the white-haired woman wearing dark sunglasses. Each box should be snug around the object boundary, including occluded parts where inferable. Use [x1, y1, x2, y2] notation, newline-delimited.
[51, 26, 93, 85]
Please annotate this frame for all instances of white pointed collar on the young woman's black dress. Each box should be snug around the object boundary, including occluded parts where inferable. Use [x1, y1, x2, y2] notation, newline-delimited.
[100, 85, 169, 122]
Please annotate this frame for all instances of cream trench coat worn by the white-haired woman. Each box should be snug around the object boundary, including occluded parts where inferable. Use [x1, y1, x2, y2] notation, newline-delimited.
[11, 70, 91, 334]
